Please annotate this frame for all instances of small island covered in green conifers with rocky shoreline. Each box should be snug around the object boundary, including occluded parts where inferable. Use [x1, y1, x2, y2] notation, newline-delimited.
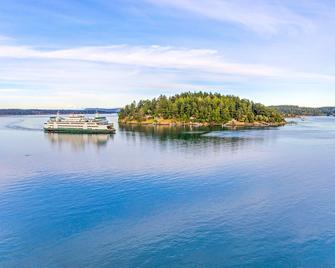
[119, 92, 285, 127]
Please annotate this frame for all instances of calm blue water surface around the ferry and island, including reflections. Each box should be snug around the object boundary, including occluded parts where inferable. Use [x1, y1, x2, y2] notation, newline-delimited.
[0, 116, 335, 267]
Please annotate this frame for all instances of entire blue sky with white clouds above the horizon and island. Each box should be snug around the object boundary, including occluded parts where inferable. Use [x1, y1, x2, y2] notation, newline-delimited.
[0, 0, 335, 109]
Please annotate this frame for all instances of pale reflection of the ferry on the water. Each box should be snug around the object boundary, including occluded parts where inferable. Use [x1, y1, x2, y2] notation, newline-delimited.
[45, 133, 112, 150]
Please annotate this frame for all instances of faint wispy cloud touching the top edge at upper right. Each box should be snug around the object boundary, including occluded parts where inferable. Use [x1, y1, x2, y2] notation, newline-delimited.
[147, 0, 314, 34]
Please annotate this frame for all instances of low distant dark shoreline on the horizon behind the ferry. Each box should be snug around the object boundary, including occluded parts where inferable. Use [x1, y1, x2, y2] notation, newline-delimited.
[0, 108, 120, 115]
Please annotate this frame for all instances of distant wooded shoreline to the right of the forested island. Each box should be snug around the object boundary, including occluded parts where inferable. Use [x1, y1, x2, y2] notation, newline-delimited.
[270, 105, 335, 116]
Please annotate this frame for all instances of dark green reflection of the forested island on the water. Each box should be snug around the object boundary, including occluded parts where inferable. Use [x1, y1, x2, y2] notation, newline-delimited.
[119, 124, 277, 152]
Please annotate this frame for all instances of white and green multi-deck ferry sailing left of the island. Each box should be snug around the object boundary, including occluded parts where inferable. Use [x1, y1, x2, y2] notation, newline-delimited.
[43, 113, 115, 134]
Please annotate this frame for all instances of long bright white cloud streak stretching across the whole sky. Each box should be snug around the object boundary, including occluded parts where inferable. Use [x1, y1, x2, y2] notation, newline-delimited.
[0, 45, 334, 79]
